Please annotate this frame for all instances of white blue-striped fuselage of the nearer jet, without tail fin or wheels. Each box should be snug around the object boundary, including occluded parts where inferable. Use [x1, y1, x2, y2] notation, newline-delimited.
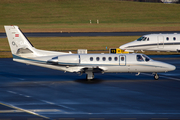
[14, 53, 175, 73]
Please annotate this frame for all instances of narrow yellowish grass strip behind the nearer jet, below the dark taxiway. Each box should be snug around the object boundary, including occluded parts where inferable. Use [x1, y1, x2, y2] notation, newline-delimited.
[0, 36, 179, 58]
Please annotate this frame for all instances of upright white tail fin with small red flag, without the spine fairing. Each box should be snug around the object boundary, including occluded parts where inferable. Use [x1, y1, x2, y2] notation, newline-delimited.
[4, 26, 35, 57]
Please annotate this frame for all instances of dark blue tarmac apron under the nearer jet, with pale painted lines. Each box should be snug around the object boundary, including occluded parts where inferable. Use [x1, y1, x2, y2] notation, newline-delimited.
[0, 55, 180, 120]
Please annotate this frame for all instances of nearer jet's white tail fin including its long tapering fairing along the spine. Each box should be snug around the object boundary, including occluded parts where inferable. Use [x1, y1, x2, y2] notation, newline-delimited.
[4, 26, 71, 58]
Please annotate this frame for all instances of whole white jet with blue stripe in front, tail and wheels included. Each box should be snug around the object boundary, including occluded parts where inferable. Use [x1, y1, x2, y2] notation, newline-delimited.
[4, 26, 176, 81]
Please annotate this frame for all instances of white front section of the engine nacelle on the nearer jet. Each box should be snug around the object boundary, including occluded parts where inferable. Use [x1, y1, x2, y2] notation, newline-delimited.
[58, 54, 80, 65]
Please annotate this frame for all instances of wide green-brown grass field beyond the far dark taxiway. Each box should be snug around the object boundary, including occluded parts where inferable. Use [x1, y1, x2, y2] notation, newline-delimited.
[0, 0, 180, 32]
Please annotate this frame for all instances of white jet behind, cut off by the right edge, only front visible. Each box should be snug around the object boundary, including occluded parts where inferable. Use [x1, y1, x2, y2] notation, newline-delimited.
[119, 33, 180, 52]
